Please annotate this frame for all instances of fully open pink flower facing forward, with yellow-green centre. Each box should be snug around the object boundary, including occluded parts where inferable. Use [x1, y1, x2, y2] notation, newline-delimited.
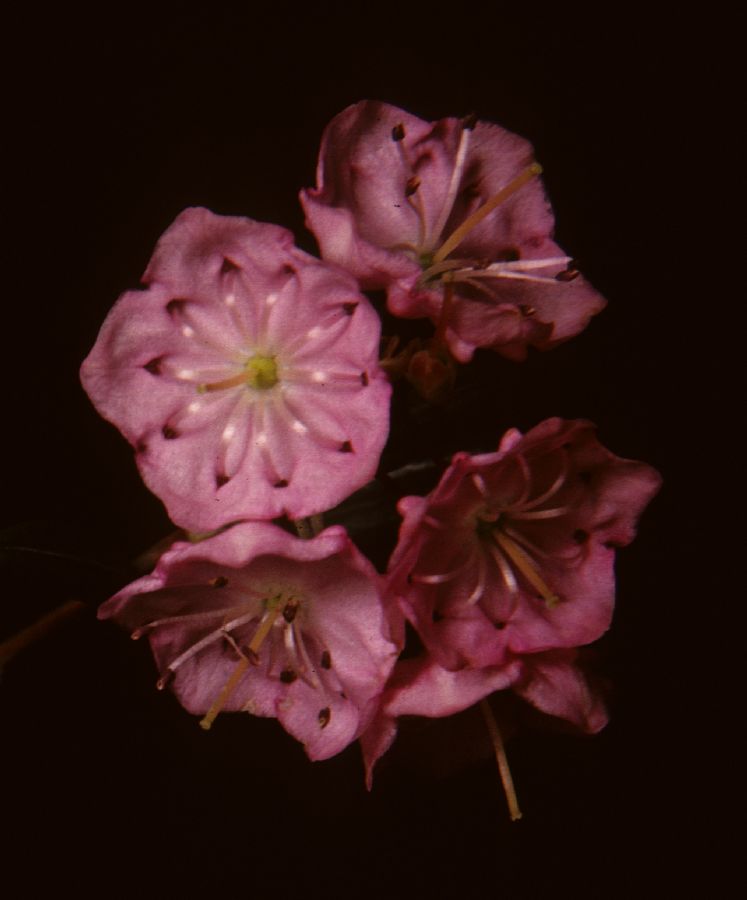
[81, 209, 390, 531]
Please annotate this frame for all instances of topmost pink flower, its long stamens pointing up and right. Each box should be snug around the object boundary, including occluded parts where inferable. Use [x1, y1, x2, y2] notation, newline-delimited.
[301, 101, 605, 362]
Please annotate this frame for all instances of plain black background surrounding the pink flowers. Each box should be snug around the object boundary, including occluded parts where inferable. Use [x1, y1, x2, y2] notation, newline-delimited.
[0, 2, 719, 898]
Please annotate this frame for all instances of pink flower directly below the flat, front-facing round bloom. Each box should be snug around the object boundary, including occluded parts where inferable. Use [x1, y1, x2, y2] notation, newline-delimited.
[99, 522, 398, 759]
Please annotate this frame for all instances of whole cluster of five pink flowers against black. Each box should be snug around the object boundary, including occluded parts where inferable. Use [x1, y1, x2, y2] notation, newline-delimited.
[81, 101, 659, 783]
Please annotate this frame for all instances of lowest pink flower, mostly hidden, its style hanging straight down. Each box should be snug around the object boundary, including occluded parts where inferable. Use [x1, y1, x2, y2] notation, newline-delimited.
[361, 649, 607, 790]
